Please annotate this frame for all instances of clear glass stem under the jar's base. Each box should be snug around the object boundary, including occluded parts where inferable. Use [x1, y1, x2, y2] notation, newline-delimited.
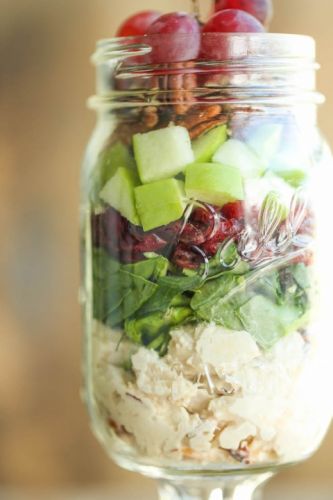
[159, 474, 271, 500]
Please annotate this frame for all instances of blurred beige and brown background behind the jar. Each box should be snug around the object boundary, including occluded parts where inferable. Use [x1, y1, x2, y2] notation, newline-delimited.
[0, 0, 333, 500]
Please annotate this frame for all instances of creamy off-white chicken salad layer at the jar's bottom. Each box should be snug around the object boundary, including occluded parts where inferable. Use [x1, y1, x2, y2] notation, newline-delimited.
[93, 322, 328, 466]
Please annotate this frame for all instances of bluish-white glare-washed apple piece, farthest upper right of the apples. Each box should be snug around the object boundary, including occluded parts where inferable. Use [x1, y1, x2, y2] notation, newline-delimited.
[246, 123, 282, 167]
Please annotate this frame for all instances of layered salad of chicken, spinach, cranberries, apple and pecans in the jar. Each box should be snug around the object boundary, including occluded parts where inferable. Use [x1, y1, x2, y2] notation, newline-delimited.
[85, 2, 327, 468]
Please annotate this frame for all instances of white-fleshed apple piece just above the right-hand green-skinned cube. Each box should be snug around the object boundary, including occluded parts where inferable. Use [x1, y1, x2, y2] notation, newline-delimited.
[213, 139, 265, 179]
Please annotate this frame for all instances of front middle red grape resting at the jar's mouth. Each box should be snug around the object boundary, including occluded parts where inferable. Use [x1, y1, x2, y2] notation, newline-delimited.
[147, 12, 200, 63]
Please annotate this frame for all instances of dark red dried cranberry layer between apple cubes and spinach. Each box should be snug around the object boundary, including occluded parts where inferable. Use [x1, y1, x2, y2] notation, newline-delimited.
[92, 202, 314, 269]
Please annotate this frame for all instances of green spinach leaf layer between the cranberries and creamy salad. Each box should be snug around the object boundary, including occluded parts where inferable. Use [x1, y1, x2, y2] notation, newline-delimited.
[93, 246, 310, 355]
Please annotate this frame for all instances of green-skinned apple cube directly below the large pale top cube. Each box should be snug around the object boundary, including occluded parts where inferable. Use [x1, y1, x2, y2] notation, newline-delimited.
[134, 179, 186, 231]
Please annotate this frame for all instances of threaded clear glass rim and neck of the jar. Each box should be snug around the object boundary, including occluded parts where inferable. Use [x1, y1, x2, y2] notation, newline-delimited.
[89, 33, 323, 109]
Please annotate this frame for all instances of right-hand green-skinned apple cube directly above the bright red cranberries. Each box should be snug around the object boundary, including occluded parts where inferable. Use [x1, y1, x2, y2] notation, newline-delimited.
[185, 163, 244, 207]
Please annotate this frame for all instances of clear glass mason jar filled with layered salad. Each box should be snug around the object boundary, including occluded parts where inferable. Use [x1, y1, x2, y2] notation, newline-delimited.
[81, 34, 333, 499]
